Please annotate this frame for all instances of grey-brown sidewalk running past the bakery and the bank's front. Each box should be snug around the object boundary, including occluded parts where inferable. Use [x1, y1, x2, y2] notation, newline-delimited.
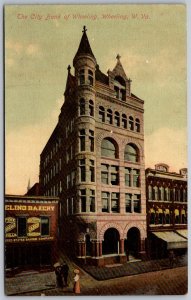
[5, 255, 187, 295]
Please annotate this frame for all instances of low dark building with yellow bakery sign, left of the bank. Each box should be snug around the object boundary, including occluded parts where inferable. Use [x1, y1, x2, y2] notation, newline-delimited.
[5, 195, 59, 271]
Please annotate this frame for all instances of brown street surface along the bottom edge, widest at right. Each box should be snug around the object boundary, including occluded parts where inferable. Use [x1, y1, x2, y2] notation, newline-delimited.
[16, 267, 188, 296]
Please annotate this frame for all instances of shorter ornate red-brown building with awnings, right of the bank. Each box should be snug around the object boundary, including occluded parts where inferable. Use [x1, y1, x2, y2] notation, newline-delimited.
[146, 164, 187, 258]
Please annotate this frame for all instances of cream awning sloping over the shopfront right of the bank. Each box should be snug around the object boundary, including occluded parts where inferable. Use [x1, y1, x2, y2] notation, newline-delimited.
[153, 231, 188, 249]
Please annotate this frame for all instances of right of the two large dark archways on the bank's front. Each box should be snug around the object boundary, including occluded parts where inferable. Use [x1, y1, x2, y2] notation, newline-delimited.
[125, 227, 140, 257]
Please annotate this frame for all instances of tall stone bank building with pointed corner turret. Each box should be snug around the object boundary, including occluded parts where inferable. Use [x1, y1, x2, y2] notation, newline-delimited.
[40, 27, 146, 265]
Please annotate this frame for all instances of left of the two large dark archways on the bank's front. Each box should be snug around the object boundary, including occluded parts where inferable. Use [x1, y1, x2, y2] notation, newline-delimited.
[102, 228, 119, 255]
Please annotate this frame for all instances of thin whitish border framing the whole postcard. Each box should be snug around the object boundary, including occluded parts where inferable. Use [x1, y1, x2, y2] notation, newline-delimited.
[0, 0, 191, 300]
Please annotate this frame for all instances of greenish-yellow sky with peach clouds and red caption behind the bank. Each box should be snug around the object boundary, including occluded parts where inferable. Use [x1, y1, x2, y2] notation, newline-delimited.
[4, 4, 187, 194]
